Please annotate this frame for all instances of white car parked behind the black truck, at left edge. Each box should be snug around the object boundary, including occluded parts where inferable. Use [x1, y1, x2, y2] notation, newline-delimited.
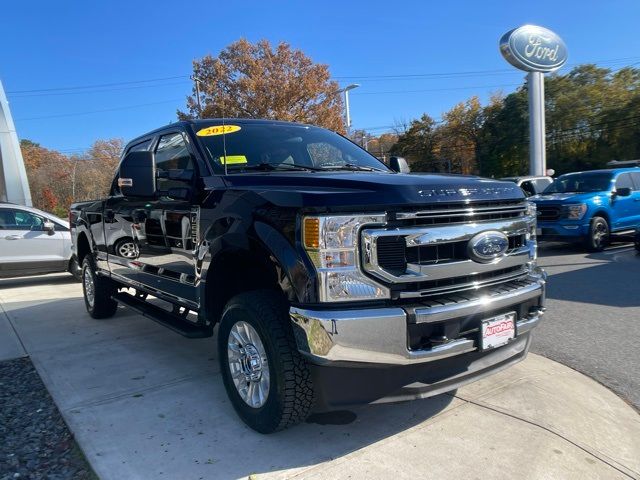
[0, 203, 79, 278]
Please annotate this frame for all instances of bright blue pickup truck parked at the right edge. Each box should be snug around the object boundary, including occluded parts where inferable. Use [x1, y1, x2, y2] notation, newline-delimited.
[530, 167, 640, 252]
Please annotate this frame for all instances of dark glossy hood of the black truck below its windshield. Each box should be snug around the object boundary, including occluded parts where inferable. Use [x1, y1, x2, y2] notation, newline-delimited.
[210, 172, 524, 209]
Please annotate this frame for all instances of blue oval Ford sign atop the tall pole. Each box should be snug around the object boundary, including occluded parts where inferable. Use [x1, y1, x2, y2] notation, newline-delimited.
[500, 25, 568, 72]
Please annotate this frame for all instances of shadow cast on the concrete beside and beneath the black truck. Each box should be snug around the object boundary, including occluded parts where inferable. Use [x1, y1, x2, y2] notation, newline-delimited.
[3, 292, 461, 478]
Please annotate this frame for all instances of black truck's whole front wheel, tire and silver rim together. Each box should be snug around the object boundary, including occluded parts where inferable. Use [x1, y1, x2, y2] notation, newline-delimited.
[218, 290, 314, 433]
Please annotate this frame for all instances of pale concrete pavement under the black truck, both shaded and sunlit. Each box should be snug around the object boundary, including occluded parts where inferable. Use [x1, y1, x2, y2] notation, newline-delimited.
[0, 276, 640, 480]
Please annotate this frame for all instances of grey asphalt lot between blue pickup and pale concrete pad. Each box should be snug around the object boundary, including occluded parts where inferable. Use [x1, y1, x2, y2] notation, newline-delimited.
[531, 243, 640, 410]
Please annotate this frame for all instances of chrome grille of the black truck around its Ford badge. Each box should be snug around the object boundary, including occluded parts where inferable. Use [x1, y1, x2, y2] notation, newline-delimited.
[362, 201, 535, 298]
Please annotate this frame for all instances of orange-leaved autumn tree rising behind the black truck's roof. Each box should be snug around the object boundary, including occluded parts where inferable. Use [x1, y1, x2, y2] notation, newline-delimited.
[178, 39, 344, 132]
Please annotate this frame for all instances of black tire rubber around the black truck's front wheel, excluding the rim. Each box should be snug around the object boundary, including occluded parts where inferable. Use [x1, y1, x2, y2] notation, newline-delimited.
[218, 290, 315, 433]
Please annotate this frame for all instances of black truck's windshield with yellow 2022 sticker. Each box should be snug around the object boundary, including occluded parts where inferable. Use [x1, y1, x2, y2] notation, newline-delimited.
[196, 121, 391, 173]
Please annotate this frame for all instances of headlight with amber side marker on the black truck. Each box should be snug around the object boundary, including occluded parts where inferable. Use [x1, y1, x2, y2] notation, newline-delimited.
[302, 214, 390, 302]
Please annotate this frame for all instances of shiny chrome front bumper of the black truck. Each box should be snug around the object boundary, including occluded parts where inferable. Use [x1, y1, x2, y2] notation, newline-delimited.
[290, 270, 546, 365]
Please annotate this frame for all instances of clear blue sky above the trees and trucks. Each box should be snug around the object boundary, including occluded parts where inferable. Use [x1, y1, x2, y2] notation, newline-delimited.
[0, 0, 640, 153]
